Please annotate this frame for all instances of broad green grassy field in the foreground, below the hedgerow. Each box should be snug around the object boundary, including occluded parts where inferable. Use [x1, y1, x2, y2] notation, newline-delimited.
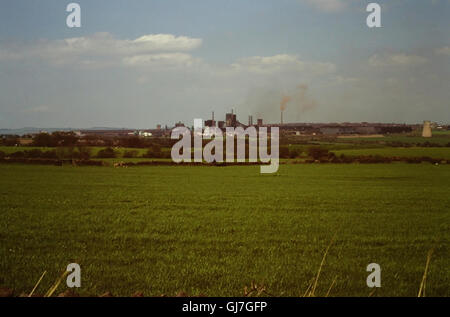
[0, 164, 450, 296]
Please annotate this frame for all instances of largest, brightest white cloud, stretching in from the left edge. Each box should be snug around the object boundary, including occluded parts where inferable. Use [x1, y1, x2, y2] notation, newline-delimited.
[0, 33, 202, 67]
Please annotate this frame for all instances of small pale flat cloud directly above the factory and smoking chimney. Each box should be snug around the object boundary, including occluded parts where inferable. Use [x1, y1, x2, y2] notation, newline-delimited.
[231, 54, 336, 75]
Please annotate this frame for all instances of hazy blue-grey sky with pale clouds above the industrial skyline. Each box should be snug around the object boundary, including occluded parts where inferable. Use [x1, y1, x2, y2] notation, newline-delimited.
[0, 0, 450, 129]
